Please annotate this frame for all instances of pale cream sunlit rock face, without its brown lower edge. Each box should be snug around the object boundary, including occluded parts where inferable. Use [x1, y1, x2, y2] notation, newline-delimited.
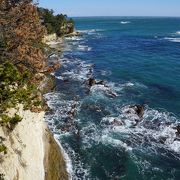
[0, 106, 45, 180]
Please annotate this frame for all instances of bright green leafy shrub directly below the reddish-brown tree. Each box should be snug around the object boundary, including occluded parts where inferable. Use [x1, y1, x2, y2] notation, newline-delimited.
[0, 61, 40, 113]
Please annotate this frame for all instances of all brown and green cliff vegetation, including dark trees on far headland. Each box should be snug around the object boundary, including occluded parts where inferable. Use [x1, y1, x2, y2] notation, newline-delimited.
[0, 0, 74, 179]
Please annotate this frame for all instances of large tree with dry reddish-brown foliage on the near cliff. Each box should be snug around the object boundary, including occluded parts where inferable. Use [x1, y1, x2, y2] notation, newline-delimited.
[0, 0, 46, 72]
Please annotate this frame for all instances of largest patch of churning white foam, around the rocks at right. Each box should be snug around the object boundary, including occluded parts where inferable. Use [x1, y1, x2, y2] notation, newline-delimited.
[101, 106, 180, 154]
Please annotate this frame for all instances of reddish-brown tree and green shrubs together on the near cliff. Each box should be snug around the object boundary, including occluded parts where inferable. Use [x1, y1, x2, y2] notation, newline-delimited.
[0, 0, 46, 127]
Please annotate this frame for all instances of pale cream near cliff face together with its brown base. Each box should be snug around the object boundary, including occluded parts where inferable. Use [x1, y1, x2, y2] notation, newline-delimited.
[0, 106, 68, 180]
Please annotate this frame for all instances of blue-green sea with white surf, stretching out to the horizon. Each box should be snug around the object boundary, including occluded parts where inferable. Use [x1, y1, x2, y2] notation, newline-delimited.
[46, 17, 180, 180]
